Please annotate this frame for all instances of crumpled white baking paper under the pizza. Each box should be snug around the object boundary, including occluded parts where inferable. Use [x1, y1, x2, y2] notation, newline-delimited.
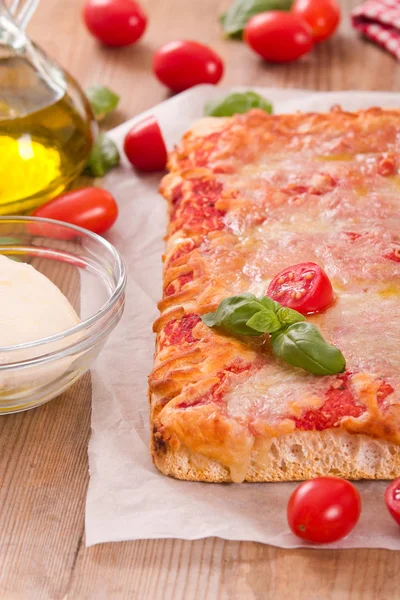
[86, 86, 400, 549]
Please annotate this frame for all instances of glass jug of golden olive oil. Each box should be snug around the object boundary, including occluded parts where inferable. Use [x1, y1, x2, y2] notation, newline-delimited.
[0, 0, 95, 215]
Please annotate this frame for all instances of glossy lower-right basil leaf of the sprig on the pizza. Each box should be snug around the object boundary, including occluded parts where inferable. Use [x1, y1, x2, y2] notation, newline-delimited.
[272, 322, 346, 375]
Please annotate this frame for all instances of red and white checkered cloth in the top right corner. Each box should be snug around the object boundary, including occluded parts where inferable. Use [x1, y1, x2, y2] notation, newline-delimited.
[351, 0, 400, 60]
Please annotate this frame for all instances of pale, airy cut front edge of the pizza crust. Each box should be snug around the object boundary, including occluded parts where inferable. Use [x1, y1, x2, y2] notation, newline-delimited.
[152, 430, 400, 483]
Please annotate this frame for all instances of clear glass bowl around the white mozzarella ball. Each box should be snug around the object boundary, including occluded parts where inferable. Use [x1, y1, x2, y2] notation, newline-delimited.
[0, 217, 126, 414]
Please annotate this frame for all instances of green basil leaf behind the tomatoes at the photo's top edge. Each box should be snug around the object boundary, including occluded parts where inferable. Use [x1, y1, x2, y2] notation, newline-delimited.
[220, 0, 293, 39]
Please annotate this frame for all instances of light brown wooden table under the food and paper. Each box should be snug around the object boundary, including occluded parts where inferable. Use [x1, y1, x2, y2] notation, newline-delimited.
[0, 0, 400, 600]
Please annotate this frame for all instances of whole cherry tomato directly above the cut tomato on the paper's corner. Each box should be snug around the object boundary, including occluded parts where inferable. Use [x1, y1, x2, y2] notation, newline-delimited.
[153, 40, 224, 92]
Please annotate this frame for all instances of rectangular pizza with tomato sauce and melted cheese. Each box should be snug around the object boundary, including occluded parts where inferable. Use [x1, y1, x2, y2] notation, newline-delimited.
[149, 107, 400, 482]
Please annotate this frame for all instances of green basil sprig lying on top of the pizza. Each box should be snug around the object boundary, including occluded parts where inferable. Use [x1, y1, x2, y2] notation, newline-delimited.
[201, 293, 346, 375]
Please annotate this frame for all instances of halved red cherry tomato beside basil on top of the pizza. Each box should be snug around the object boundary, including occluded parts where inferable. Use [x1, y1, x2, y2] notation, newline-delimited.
[267, 262, 334, 315]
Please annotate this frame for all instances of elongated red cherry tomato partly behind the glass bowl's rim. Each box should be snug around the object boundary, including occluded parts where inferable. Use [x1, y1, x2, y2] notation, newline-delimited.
[32, 187, 118, 239]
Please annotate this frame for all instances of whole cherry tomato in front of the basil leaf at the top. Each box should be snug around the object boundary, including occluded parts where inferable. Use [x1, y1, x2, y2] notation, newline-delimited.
[244, 10, 313, 63]
